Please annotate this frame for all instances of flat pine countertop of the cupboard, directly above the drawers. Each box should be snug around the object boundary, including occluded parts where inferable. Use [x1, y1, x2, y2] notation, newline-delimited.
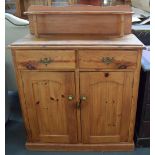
[11, 34, 144, 48]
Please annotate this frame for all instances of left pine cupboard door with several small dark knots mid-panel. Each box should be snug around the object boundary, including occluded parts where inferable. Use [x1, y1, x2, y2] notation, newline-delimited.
[21, 71, 77, 143]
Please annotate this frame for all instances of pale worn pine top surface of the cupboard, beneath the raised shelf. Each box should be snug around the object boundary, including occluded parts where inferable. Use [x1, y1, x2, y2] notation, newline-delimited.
[11, 34, 144, 50]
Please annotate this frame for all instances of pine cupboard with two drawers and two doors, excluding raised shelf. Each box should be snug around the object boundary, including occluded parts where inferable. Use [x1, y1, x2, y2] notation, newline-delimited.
[11, 34, 143, 151]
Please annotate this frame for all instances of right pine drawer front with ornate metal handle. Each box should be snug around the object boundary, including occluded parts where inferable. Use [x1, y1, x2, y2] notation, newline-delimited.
[79, 50, 137, 69]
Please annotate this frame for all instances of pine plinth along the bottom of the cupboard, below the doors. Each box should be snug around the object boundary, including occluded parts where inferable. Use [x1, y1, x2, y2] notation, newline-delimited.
[26, 143, 134, 151]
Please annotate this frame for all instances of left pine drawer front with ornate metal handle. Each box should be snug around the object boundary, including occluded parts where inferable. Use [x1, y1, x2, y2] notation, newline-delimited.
[15, 50, 75, 70]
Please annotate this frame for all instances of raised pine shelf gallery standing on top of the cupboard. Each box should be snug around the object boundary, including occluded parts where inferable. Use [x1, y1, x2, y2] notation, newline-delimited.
[26, 5, 132, 37]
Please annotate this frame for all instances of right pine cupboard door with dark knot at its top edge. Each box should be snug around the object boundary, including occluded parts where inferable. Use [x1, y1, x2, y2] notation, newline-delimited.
[80, 72, 133, 143]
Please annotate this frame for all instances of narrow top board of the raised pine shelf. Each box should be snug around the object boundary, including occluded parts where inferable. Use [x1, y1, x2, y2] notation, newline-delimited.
[25, 5, 132, 14]
